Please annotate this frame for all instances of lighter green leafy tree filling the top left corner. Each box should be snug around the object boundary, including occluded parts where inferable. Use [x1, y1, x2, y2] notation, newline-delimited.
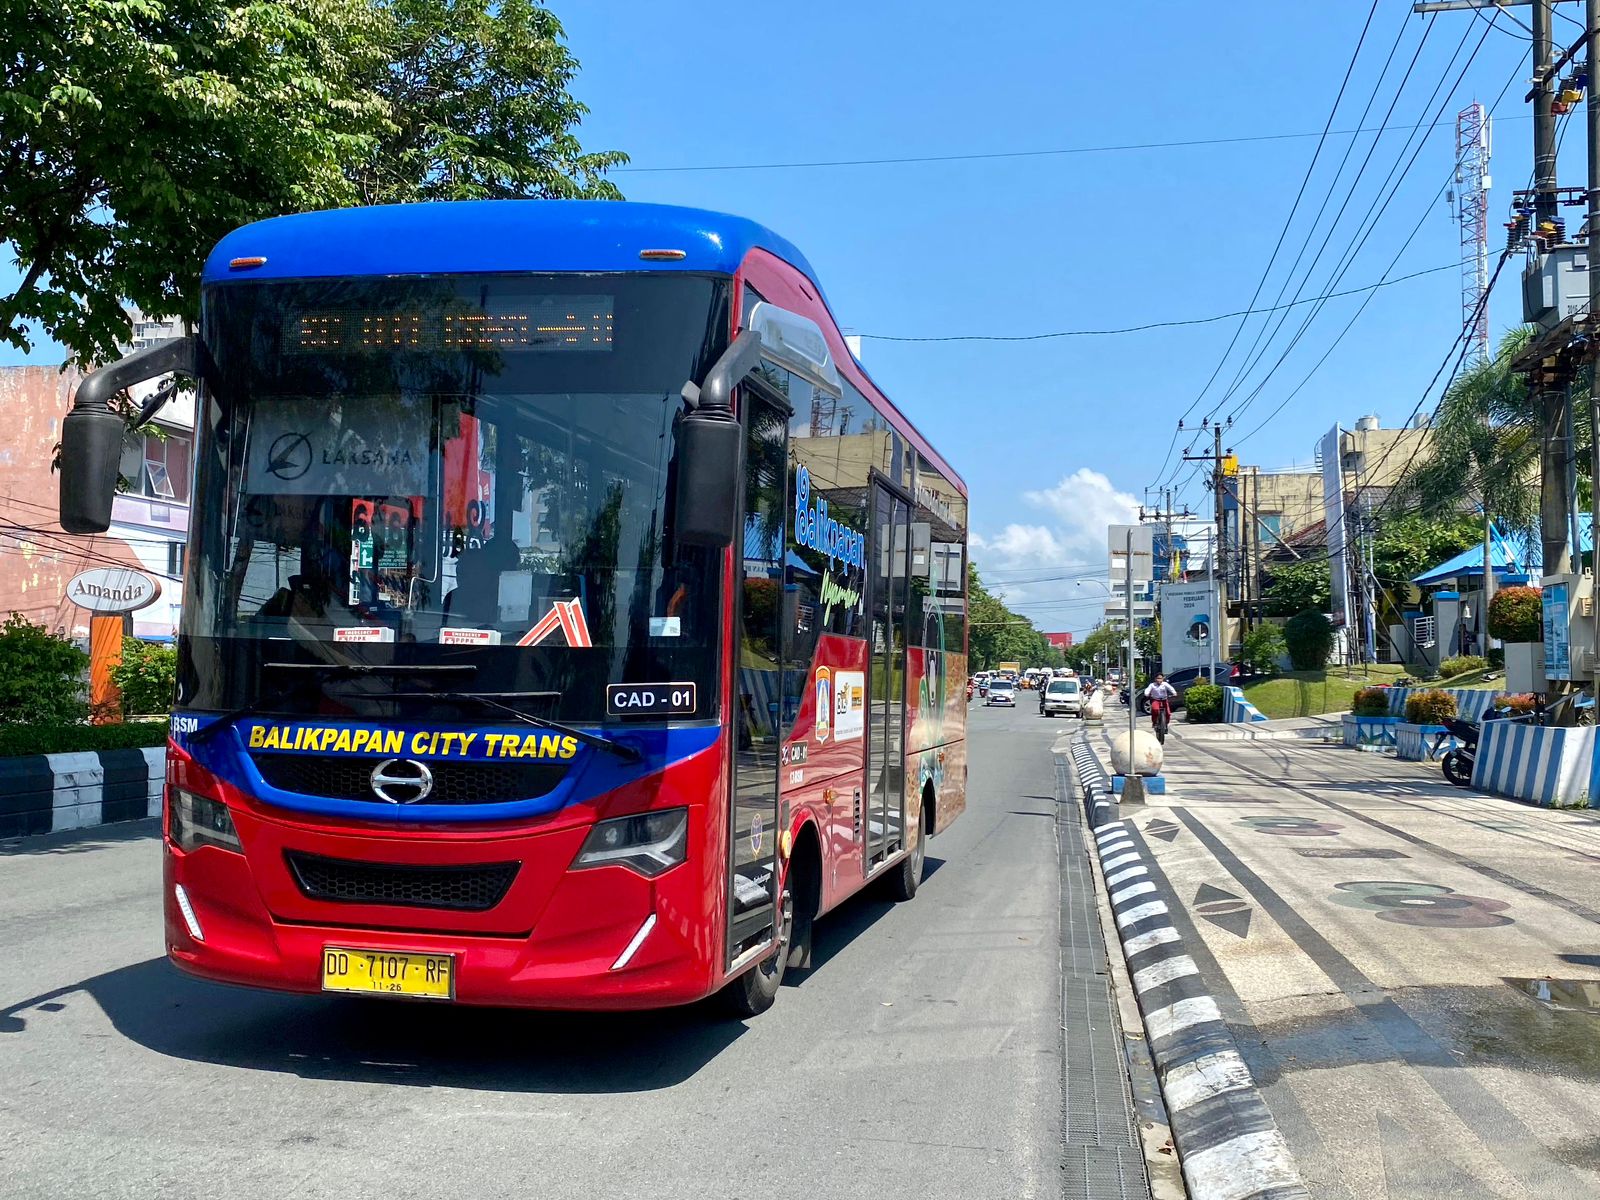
[0, 0, 387, 363]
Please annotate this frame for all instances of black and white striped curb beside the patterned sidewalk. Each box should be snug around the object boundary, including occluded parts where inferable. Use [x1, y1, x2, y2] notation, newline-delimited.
[1080, 825, 1310, 1200]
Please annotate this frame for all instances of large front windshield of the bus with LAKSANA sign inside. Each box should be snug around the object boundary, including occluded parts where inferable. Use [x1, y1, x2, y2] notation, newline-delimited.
[179, 275, 731, 720]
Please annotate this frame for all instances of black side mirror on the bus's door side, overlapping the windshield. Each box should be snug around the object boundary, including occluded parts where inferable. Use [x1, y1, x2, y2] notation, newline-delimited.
[674, 330, 762, 550]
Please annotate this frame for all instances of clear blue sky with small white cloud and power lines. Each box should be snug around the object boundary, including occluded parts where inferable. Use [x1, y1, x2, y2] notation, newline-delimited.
[0, 0, 1584, 632]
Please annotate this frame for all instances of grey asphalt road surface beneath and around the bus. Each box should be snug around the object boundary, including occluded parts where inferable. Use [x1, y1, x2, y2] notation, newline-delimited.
[0, 704, 1088, 1200]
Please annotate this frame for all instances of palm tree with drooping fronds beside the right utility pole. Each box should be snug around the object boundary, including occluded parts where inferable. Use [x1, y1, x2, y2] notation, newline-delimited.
[1410, 326, 1542, 553]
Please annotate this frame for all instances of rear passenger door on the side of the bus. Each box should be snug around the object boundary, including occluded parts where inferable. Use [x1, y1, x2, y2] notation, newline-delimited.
[866, 482, 910, 875]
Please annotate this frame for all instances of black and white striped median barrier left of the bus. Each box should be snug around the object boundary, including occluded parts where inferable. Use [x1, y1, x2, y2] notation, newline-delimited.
[0, 746, 166, 837]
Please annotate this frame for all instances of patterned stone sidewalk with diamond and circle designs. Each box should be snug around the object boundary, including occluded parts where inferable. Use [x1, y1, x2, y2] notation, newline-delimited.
[1133, 731, 1600, 1200]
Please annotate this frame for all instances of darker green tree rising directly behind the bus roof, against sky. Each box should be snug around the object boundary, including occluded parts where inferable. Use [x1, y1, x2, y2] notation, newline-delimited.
[352, 0, 627, 203]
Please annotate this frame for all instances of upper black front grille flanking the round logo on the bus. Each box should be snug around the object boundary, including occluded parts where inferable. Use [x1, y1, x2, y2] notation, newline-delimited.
[251, 754, 566, 805]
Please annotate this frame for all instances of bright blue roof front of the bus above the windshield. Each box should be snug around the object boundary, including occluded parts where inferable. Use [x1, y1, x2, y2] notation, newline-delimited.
[202, 200, 821, 288]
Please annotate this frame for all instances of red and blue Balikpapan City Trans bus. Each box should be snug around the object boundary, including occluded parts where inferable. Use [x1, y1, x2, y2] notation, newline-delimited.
[61, 202, 966, 1014]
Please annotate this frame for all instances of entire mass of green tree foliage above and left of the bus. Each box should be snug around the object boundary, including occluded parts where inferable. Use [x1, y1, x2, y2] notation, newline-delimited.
[0, 0, 622, 365]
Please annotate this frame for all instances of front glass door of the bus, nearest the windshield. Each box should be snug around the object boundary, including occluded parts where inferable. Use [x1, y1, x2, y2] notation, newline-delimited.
[726, 392, 789, 965]
